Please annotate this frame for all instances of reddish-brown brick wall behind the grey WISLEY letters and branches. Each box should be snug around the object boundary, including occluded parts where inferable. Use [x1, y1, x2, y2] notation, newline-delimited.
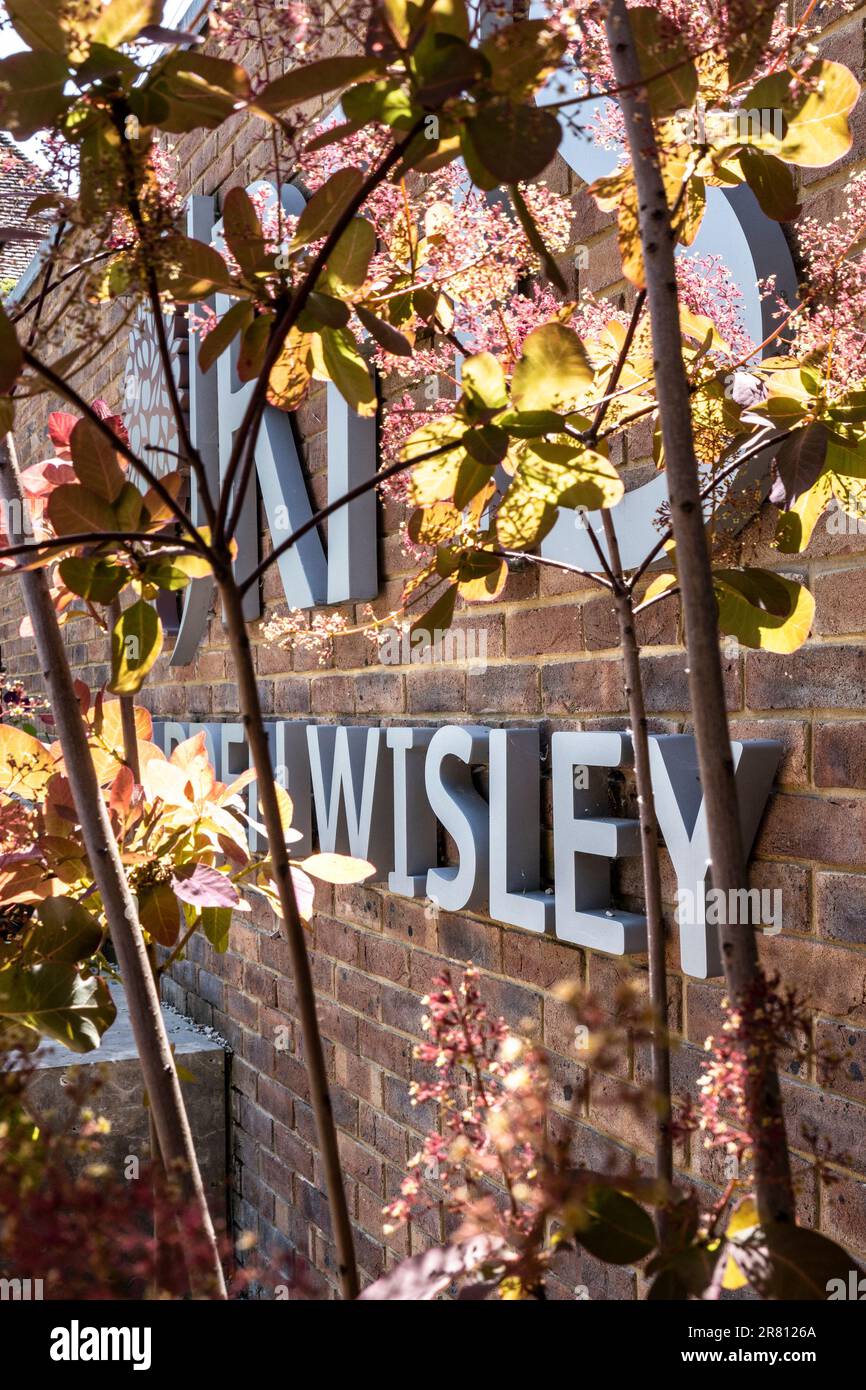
[0, 10, 866, 1298]
